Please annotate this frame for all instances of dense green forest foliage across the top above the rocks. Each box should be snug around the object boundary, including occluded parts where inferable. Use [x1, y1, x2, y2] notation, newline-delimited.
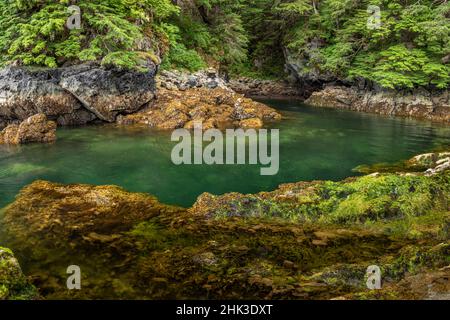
[0, 0, 450, 88]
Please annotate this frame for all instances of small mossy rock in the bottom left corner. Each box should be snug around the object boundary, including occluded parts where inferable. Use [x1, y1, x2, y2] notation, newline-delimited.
[0, 247, 39, 300]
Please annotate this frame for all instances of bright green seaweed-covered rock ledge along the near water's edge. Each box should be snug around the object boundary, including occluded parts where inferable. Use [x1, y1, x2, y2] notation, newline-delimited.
[189, 170, 450, 224]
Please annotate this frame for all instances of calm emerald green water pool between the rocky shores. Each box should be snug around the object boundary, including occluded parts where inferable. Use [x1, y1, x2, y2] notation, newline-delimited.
[0, 101, 450, 207]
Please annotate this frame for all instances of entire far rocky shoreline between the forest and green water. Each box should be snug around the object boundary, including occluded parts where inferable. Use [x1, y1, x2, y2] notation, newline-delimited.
[0, 63, 450, 141]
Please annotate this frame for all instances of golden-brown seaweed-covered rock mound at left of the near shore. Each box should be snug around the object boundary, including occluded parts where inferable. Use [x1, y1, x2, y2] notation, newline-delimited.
[2, 181, 180, 246]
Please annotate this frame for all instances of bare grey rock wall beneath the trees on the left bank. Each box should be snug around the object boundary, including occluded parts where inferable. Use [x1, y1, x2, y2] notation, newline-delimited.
[0, 63, 157, 129]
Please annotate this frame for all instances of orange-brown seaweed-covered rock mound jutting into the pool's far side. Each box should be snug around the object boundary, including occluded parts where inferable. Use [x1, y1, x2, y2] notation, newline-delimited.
[117, 88, 281, 130]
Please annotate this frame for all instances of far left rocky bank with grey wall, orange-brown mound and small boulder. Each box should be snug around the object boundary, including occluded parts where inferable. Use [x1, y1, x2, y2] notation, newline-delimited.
[0, 63, 281, 144]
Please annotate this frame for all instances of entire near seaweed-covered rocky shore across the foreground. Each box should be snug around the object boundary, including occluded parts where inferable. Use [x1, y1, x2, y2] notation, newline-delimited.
[0, 153, 450, 299]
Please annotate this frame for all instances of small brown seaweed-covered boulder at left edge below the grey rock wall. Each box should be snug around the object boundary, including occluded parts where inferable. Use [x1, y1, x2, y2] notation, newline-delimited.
[0, 113, 56, 144]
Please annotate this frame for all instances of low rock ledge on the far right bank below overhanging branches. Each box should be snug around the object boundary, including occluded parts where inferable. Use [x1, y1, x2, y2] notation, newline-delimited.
[306, 86, 450, 122]
